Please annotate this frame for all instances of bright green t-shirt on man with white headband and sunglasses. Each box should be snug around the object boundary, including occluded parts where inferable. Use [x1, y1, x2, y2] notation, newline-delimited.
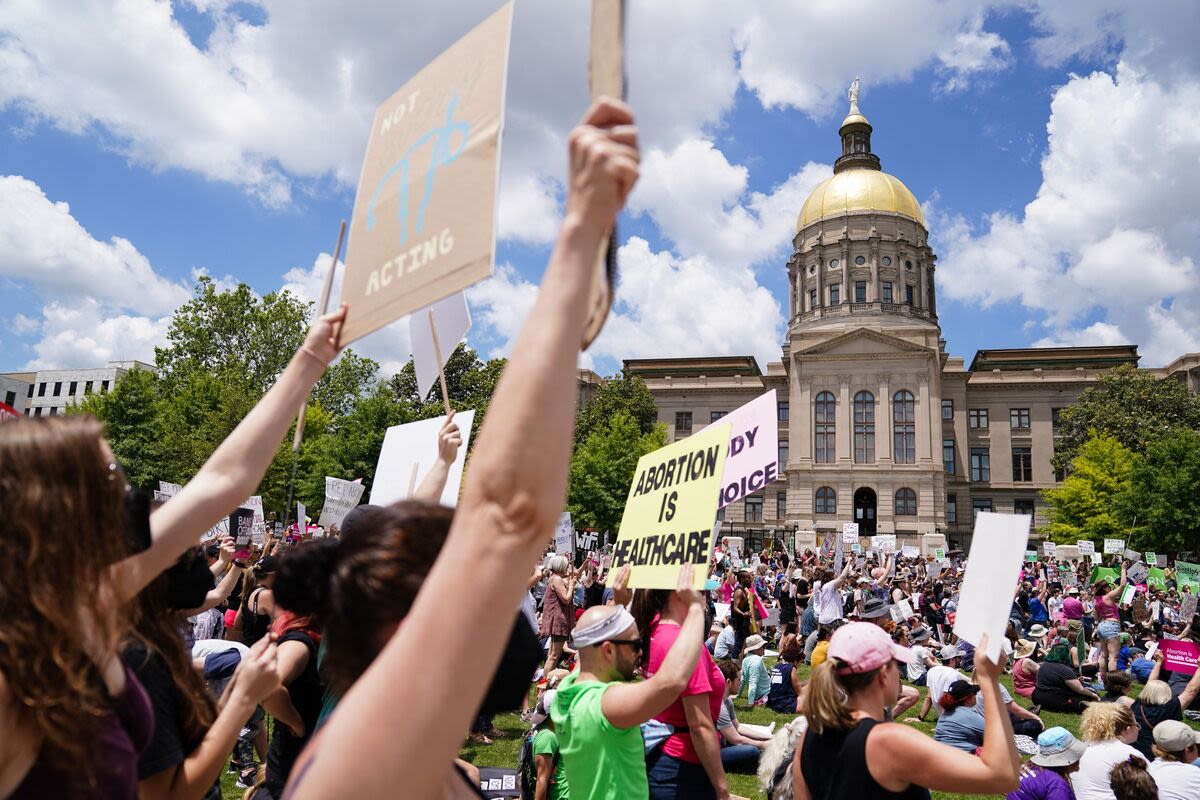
[550, 673, 650, 800]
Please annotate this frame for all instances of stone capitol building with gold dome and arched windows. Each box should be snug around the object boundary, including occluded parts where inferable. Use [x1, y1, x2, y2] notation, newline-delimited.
[625, 82, 1200, 547]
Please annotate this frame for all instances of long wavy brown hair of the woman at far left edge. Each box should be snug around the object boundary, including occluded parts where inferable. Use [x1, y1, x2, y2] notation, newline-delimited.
[0, 416, 128, 787]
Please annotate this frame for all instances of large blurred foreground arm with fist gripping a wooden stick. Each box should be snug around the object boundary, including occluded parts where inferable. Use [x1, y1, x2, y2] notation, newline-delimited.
[290, 100, 638, 800]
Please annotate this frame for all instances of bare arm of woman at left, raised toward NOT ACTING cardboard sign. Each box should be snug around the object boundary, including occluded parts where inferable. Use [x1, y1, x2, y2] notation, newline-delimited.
[113, 306, 346, 601]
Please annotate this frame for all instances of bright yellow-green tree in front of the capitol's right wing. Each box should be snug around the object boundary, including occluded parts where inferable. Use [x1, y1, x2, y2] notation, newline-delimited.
[1042, 434, 1136, 552]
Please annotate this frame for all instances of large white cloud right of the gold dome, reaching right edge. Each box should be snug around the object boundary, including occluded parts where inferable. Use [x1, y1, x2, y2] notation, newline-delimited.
[934, 62, 1200, 365]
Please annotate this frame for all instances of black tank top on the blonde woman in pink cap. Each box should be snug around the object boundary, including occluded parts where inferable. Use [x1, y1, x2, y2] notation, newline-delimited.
[800, 718, 930, 800]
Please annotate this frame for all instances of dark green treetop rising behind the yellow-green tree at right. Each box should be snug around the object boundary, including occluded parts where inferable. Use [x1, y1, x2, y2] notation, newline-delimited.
[1054, 365, 1200, 469]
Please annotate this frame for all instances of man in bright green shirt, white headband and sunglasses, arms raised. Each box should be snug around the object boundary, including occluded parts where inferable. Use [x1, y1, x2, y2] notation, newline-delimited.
[550, 565, 704, 800]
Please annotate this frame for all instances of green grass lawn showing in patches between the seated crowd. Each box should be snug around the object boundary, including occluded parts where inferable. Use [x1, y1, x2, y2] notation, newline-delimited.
[451, 660, 1200, 800]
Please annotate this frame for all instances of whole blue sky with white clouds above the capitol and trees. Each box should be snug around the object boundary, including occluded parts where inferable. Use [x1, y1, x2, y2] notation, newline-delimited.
[0, 0, 1200, 373]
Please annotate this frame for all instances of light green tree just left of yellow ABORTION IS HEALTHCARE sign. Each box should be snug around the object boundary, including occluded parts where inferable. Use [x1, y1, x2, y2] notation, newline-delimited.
[566, 410, 667, 530]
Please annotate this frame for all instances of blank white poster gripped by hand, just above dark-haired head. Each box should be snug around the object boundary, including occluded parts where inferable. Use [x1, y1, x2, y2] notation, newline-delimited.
[371, 411, 475, 507]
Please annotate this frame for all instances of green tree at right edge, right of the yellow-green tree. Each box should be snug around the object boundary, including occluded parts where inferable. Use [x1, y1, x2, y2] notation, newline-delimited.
[1116, 429, 1200, 553]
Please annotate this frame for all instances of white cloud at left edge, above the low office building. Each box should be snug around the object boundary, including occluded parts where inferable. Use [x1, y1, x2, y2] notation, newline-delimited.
[0, 175, 188, 314]
